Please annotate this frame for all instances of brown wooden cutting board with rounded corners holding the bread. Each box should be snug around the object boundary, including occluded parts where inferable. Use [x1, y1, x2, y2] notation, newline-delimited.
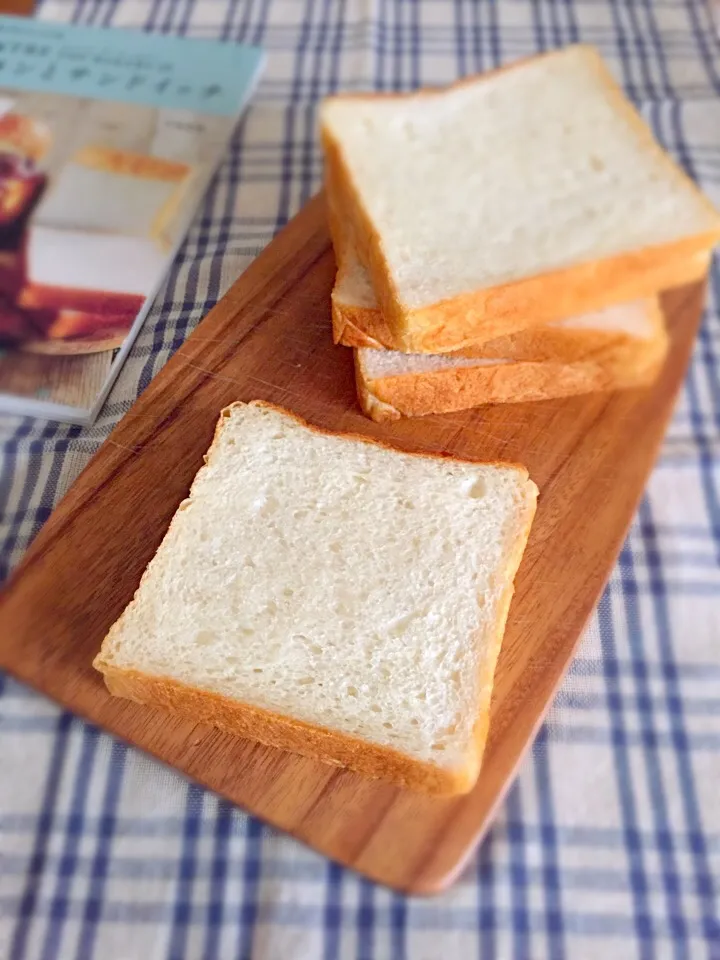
[0, 198, 703, 892]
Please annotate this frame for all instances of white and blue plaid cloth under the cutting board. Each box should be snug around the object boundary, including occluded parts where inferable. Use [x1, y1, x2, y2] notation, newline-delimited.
[0, 0, 720, 960]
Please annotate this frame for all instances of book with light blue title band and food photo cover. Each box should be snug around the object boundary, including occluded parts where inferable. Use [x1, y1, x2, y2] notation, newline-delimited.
[0, 17, 263, 423]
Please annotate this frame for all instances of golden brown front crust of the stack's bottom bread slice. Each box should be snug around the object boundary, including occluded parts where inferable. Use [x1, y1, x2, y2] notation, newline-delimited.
[355, 329, 668, 422]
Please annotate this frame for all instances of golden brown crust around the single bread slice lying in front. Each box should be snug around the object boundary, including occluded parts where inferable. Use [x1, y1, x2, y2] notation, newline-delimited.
[93, 400, 537, 795]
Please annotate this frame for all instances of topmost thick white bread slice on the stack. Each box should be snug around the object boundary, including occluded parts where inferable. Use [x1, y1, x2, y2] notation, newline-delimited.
[321, 46, 720, 353]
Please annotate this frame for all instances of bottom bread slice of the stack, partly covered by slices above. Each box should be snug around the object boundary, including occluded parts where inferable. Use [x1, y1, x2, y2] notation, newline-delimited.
[355, 300, 668, 421]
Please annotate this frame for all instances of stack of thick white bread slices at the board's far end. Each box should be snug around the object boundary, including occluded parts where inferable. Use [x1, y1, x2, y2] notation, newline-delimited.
[321, 45, 720, 420]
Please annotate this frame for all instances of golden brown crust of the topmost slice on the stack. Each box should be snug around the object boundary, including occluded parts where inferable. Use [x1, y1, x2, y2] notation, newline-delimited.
[321, 48, 720, 353]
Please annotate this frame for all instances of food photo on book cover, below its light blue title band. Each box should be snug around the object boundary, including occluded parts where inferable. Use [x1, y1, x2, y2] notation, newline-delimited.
[0, 88, 242, 409]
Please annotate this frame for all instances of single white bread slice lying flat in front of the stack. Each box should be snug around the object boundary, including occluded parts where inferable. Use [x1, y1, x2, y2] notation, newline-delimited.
[94, 403, 537, 793]
